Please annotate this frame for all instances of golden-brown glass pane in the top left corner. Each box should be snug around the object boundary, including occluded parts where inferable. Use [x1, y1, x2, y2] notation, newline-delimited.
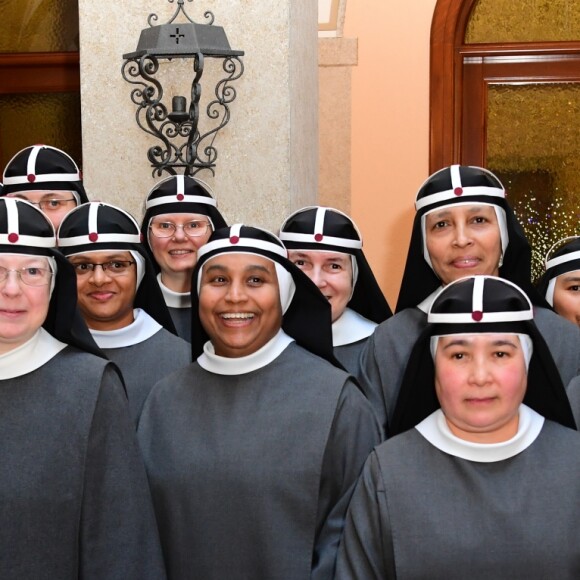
[0, 0, 79, 52]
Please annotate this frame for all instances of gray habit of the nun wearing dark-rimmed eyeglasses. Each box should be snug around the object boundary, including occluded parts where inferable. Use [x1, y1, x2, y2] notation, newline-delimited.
[101, 328, 191, 424]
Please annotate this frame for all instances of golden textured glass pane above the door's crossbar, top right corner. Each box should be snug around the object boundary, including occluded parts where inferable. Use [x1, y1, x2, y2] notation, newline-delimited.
[465, 0, 580, 44]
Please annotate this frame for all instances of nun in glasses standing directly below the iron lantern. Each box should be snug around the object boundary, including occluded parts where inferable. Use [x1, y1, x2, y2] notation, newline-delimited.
[141, 175, 226, 342]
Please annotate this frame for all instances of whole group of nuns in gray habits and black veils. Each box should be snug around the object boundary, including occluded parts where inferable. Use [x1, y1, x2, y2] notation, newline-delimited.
[0, 145, 580, 580]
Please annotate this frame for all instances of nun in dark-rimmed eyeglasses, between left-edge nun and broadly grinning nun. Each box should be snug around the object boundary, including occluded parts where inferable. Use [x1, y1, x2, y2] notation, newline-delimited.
[58, 202, 191, 423]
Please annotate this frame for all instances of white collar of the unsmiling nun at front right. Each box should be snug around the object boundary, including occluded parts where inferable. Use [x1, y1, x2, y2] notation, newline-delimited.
[415, 404, 544, 463]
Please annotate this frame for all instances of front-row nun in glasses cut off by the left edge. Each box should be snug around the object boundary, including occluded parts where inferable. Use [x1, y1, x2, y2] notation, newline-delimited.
[0, 198, 165, 580]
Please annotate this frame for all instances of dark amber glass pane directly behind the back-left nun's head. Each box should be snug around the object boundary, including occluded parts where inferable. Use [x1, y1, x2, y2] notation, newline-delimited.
[0, 93, 82, 169]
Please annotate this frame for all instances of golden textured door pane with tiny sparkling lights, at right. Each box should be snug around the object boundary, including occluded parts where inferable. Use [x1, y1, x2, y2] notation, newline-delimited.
[486, 83, 580, 277]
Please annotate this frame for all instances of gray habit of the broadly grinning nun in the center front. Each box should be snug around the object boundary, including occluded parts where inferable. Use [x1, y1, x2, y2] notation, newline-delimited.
[138, 343, 380, 580]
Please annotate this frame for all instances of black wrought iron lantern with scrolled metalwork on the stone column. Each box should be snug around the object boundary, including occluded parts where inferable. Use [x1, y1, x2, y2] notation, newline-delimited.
[122, 0, 244, 177]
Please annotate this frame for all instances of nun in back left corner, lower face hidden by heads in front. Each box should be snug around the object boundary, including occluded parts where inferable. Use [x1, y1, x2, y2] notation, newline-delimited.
[0, 145, 89, 230]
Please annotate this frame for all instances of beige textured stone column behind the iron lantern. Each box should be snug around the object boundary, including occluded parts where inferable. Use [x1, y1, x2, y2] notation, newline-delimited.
[79, 0, 318, 230]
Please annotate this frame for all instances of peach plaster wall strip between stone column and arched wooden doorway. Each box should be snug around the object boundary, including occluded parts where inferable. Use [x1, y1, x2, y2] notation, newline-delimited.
[344, 0, 436, 307]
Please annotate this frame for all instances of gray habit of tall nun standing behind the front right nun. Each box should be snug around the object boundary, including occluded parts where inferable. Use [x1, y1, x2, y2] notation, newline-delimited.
[358, 307, 580, 435]
